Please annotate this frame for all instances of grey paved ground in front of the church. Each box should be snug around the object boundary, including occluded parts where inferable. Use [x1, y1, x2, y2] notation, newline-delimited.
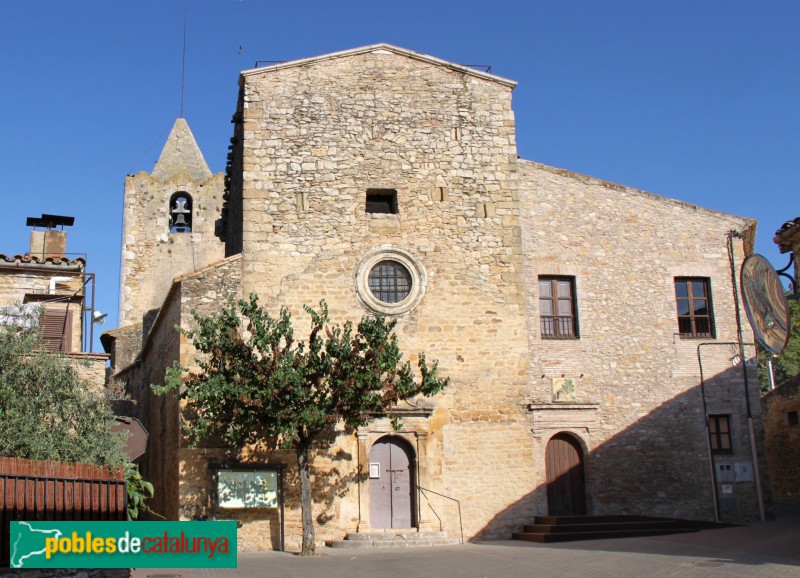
[133, 508, 800, 578]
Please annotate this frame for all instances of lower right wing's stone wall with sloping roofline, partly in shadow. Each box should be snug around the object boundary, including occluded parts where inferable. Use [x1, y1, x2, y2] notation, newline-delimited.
[520, 161, 766, 520]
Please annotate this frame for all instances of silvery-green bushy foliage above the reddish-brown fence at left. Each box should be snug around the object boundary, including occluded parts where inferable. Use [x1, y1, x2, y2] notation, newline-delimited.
[0, 311, 125, 466]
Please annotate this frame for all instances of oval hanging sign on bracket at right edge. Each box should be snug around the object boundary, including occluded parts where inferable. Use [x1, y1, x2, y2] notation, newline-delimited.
[741, 255, 791, 353]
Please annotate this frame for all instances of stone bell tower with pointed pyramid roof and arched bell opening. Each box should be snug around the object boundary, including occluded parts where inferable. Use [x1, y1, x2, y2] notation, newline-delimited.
[119, 118, 225, 327]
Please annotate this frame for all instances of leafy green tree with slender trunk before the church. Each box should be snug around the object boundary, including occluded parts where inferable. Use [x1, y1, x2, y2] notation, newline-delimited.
[153, 295, 448, 555]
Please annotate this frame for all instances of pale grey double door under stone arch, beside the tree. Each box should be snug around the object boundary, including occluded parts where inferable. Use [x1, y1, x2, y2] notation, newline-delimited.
[369, 436, 416, 529]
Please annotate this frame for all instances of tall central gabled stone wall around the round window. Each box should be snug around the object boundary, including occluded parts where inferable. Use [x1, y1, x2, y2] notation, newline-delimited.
[228, 49, 533, 537]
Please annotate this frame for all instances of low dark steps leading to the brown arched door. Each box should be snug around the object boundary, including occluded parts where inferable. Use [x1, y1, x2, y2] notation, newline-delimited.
[513, 516, 698, 543]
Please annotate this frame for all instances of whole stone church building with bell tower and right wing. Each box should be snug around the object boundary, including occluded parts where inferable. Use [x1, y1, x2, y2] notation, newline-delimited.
[104, 44, 769, 549]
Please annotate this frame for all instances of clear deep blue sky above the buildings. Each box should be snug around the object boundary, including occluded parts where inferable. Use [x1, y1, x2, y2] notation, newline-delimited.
[0, 0, 800, 349]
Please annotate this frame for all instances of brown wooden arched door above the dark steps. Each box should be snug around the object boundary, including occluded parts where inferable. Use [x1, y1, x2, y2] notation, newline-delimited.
[545, 433, 586, 516]
